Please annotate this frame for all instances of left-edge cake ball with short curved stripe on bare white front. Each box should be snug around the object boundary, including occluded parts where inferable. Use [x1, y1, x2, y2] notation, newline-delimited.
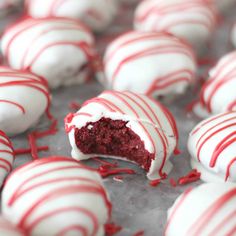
[0, 67, 51, 136]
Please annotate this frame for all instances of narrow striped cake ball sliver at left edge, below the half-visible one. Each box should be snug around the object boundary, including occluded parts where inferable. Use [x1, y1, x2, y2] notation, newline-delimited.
[0, 130, 14, 187]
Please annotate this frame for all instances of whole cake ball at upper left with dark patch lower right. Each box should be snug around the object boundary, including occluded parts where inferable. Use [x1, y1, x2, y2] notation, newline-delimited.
[2, 16, 97, 88]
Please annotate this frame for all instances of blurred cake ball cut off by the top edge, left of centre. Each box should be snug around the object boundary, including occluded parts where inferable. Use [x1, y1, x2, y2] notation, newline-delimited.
[25, 0, 118, 31]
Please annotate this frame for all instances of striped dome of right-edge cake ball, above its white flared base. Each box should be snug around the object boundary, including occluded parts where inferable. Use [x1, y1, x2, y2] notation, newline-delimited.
[189, 112, 236, 181]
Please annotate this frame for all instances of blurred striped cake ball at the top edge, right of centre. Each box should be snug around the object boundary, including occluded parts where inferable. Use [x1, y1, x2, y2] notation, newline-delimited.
[135, 0, 216, 42]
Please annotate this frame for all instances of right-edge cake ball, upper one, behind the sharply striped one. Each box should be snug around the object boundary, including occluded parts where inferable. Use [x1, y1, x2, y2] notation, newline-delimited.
[193, 51, 236, 117]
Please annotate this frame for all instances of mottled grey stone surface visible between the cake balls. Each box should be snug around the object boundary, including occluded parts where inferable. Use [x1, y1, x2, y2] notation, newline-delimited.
[2, 3, 235, 236]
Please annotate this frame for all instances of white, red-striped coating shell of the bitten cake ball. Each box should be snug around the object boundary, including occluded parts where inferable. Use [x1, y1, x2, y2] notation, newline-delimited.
[65, 91, 178, 179]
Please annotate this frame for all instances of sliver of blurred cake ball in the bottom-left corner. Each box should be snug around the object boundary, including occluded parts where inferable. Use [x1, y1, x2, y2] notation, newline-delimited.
[0, 216, 25, 236]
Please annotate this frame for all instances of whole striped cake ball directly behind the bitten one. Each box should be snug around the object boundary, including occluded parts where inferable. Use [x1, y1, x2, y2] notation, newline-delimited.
[104, 32, 196, 95]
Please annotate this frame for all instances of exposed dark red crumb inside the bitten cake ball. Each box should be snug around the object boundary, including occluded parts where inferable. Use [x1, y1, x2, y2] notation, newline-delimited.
[75, 118, 154, 171]
